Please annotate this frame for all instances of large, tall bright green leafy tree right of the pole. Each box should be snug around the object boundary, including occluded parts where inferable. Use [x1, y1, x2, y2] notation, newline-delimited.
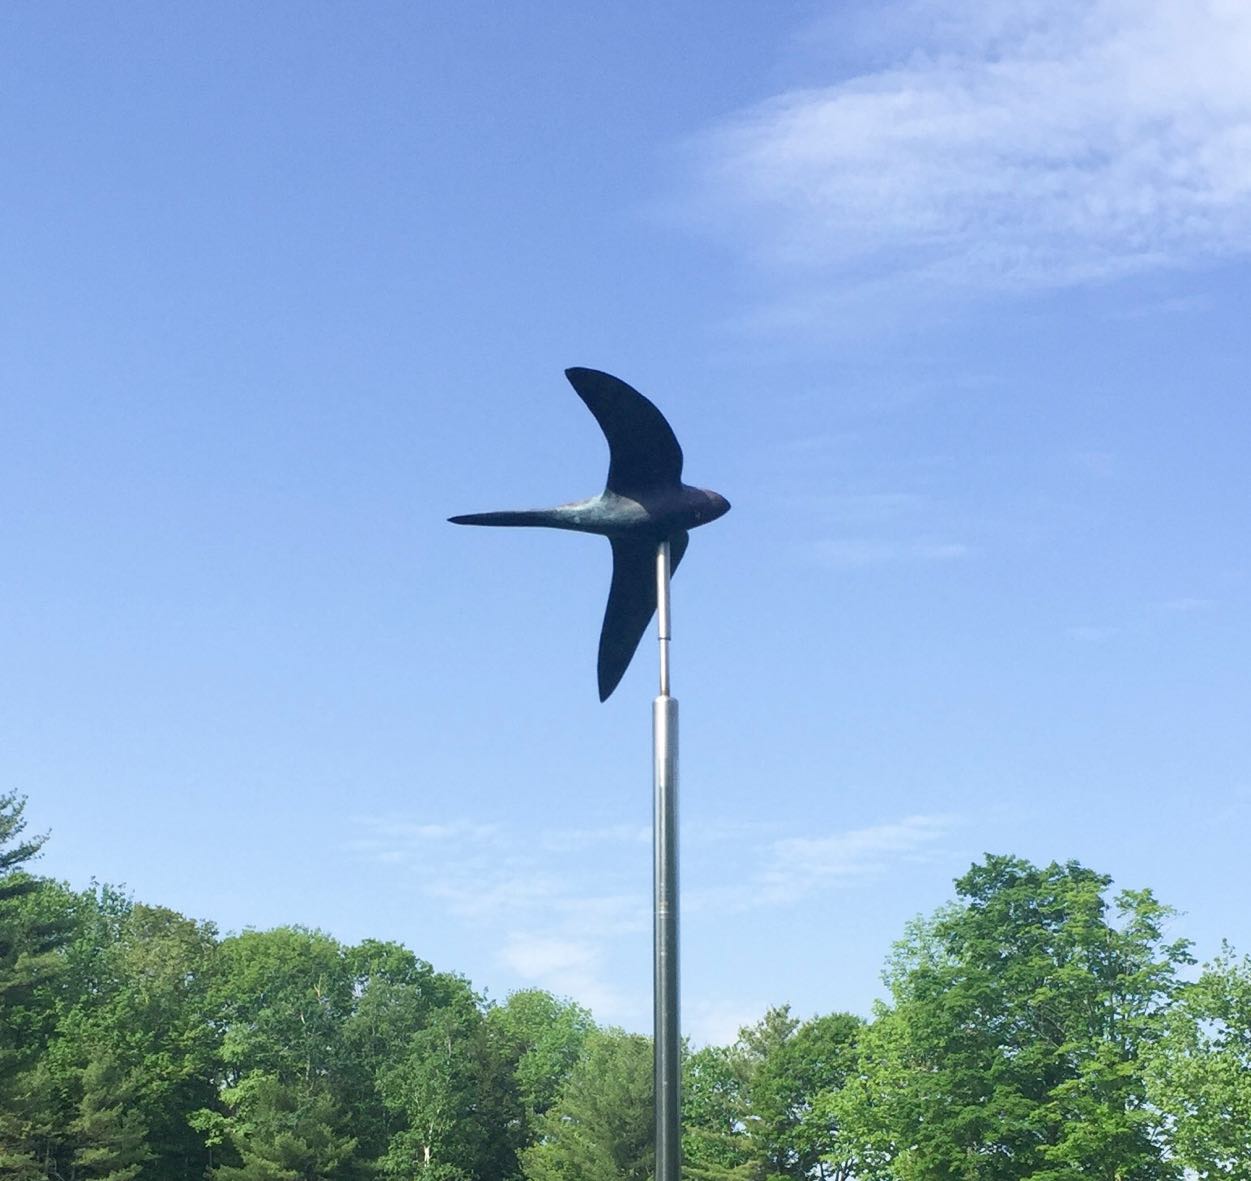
[832, 857, 1188, 1181]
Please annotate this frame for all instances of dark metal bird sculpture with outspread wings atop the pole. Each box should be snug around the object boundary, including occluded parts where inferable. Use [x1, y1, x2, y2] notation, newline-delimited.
[448, 369, 729, 701]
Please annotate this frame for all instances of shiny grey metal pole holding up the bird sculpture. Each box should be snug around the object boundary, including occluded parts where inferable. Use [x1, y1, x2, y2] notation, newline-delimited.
[652, 540, 682, 1181]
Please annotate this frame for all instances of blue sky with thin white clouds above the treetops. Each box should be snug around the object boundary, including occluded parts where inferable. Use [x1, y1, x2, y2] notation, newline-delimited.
[0, 0, 1251, 1040]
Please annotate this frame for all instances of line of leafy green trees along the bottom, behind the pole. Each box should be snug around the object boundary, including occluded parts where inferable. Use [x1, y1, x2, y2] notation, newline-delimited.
[0, 794, 1251, 1181]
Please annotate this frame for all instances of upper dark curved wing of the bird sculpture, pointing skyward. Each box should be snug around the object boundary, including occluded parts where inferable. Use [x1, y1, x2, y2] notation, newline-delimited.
[564, 369, 682, 495]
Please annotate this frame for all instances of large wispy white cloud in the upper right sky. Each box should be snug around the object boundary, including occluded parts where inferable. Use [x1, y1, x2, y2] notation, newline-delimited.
[701, 0, 1251, 288]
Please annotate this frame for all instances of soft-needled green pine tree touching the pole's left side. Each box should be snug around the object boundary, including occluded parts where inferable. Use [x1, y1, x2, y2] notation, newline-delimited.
[523, 1031, 654, 1181]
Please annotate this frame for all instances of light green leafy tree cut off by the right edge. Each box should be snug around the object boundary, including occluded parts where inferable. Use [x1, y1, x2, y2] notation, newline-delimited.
[1148, 945, 1251, 1181]
